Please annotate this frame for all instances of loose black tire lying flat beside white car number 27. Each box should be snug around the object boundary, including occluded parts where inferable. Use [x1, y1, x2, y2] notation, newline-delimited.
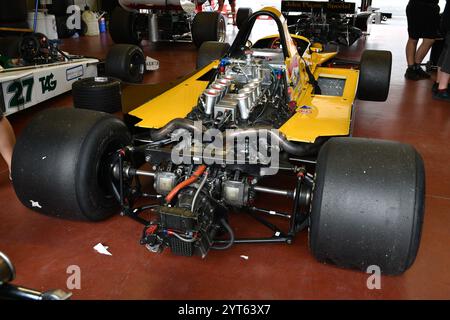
[72, 77, 122, 113]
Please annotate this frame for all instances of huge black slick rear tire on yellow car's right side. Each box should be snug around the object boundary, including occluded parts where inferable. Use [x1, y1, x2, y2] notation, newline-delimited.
[309, 138, 425, 275]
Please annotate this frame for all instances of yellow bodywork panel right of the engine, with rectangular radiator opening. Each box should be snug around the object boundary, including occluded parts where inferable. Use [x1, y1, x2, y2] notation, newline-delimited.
[280, 68, 359, 142]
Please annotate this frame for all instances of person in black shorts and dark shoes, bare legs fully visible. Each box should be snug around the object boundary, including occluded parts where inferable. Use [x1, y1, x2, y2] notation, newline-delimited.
[405, 0, 440, 80]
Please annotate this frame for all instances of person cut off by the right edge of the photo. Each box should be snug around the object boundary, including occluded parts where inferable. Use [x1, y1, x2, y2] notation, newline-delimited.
[433, 0, 450, 102]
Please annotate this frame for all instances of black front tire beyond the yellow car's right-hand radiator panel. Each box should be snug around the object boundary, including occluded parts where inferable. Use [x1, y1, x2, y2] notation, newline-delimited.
[357, 50, 392, 101]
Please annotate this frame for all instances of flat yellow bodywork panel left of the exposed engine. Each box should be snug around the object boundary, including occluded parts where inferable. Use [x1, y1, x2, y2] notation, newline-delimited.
[130, 60, 219, 129]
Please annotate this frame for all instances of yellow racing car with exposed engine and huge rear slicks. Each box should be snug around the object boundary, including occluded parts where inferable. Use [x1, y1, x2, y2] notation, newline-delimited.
[12, 8, 425, 274]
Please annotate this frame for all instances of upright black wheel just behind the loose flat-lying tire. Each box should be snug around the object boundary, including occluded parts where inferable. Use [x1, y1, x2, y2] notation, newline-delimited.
[105, 44, 145, 83]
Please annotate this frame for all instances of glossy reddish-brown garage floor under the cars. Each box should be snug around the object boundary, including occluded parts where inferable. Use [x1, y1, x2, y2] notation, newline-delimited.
[0, 19, 450, 299]
